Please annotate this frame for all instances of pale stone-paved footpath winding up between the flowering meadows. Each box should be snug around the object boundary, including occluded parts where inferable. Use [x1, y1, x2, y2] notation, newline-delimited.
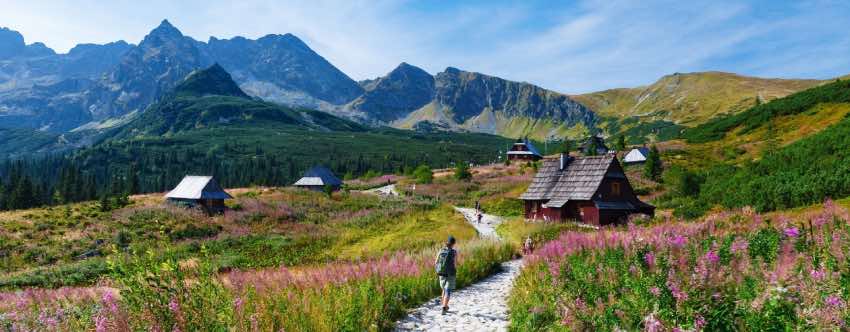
[396, 208, 522, 331]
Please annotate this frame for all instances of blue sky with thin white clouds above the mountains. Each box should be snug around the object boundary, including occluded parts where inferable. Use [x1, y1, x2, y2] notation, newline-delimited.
[0, 0, 850, 93]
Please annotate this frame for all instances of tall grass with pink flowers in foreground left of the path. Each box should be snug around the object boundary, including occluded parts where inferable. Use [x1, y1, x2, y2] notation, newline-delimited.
[0, 241, 513, 331]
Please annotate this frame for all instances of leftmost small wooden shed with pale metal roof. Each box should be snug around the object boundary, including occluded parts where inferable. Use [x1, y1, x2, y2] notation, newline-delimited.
[165, 175, 233, 214]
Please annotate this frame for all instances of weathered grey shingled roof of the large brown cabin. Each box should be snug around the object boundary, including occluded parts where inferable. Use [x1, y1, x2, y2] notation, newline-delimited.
[520, 154, 615, 201]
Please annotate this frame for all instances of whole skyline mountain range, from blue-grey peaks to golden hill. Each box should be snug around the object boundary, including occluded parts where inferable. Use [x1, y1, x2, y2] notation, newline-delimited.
[0, 20, 840, 155]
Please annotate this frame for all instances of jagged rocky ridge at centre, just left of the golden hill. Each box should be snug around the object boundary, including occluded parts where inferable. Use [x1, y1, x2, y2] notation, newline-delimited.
[346, 63, 596, 134]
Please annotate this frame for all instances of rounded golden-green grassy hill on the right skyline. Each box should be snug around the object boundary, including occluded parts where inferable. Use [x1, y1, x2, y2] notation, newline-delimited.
[573, 72, 822, 144]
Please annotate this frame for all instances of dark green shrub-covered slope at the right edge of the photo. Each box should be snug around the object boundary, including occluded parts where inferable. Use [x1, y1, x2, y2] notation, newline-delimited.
[660, 81, 850, 217]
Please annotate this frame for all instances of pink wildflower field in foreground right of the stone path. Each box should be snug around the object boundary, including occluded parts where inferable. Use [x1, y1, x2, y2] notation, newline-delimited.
[510, 200, 850, 331]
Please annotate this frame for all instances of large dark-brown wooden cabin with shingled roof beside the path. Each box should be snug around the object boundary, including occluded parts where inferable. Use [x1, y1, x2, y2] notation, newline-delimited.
[520, 154, 655, 226]
